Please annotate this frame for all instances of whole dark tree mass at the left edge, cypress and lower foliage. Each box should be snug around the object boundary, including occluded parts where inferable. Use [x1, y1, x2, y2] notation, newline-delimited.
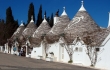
[0, 7, 18, 45]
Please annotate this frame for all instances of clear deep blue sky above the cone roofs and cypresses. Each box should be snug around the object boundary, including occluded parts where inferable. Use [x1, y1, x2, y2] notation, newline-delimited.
[0, 0, 110, 27]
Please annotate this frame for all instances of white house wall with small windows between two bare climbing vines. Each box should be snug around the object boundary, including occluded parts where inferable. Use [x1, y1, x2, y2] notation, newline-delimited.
[73, 42, 91, 66]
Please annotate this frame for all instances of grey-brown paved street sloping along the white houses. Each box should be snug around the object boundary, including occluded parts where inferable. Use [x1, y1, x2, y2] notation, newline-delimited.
[0, 53, 99, 70]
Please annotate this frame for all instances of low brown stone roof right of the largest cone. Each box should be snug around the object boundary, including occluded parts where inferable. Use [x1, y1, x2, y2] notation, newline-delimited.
[82, 28, 106, 47]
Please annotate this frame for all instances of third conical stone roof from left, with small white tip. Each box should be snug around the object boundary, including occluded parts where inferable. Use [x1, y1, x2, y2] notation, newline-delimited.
[30, 15, 51, 47]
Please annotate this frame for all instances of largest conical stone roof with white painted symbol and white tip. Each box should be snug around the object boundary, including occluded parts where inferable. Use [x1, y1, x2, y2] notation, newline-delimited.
[64, 1, 100, 39]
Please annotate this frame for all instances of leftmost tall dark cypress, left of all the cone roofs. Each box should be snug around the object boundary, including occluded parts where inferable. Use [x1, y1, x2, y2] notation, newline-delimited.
[4, 7, 18, 41]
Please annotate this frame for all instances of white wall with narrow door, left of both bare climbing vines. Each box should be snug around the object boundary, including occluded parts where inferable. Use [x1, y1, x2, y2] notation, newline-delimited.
[48, 42, 69, 62]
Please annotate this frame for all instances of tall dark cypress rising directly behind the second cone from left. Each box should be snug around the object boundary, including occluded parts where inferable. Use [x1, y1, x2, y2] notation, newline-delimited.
[27, 3, 35, 25]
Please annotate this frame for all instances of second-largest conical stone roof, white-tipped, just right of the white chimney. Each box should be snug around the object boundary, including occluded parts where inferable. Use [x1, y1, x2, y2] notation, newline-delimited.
[46, 8, 70, 42]
